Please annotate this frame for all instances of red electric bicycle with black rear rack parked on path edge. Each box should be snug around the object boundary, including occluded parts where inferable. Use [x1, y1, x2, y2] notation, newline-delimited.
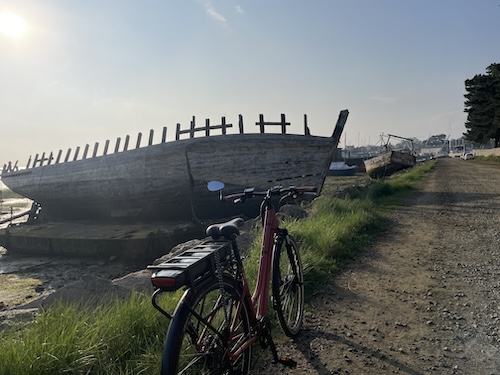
[148, 183, 315, 375]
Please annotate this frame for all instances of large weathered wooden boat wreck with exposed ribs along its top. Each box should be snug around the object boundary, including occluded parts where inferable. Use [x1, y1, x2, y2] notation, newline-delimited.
[1, 110, 348, 222]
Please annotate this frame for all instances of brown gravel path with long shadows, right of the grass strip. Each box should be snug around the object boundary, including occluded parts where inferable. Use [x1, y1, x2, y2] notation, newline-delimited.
[253, 159, 500, 375]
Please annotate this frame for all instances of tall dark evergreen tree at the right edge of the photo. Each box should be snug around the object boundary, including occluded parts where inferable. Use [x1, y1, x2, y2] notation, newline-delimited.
[464, 63, 500, 145]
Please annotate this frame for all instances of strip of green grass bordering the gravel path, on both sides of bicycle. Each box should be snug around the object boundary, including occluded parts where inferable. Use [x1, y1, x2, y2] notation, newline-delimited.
[0, 162, 434, 375]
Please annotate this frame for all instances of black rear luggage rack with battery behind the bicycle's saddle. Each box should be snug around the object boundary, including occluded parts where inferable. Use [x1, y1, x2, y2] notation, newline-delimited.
[147, 240, 231, 292]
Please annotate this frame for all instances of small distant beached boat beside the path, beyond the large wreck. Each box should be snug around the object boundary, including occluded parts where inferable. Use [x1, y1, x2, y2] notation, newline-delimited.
[364, 134, 416, 178]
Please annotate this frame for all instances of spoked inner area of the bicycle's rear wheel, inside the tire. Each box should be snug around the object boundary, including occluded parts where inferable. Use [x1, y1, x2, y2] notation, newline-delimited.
[164, 280, 250, 375]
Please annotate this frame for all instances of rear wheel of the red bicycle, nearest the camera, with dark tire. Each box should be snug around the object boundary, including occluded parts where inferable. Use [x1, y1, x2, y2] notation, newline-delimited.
[161, 276, 251, 375]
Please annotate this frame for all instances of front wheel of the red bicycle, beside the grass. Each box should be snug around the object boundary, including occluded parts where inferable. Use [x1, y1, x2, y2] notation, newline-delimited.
[272, 235, 304, 337]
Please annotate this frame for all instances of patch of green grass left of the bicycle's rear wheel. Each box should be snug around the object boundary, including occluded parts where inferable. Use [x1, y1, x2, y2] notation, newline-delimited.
[0, 294, 167, 375]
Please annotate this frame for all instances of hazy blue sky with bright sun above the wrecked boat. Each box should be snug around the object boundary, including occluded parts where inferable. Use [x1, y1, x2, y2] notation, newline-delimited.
[0, 0, 500, 166]
